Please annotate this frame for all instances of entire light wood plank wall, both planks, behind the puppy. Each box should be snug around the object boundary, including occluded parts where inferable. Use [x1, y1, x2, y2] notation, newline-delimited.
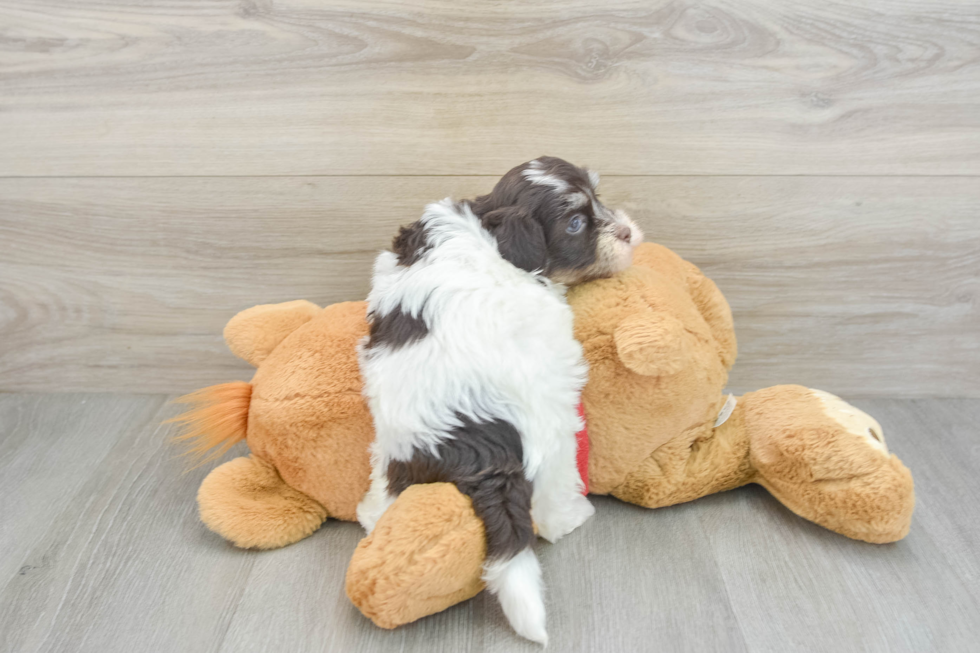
[0, 0, 980, 396]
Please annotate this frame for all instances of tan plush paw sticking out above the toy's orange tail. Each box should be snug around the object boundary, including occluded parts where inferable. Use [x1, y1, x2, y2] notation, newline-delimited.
[224, 299, 323, 367]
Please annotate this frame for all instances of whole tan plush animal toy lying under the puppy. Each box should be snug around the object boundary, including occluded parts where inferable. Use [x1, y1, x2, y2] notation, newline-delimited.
[175, 243, 915, 628]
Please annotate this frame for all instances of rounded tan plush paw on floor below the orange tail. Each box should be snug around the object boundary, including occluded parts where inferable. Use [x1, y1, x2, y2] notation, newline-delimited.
[197, 454, 327, 549]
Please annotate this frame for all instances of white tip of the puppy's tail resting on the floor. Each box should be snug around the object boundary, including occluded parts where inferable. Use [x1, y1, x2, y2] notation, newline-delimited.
[483, 546, 548, 646]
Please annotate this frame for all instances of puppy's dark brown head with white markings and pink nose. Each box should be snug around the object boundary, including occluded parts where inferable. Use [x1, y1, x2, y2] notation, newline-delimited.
[472, 156, 643, 285]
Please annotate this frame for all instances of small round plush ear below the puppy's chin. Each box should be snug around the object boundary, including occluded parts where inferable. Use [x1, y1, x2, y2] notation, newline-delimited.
[613, 308, 689, 376]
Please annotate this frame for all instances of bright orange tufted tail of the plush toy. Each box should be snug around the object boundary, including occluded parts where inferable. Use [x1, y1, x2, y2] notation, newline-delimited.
[164, 381, 252, 464]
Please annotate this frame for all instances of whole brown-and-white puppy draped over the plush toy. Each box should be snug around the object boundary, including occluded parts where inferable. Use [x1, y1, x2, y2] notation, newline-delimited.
[357, 157, 642, 643]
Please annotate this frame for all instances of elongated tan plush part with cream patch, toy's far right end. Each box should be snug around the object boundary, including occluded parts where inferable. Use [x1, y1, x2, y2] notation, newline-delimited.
[740, 386, 915, 543]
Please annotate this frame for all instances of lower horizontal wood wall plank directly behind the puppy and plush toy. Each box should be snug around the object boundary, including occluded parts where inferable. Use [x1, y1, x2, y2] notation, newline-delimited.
[0, 177, 980, 396]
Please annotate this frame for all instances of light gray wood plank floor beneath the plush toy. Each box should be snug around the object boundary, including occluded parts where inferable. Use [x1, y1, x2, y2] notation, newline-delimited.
[0, 394, 980, 653]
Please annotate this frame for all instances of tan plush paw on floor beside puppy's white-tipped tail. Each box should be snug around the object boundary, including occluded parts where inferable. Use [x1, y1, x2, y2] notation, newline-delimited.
[346, 483, 486, 628]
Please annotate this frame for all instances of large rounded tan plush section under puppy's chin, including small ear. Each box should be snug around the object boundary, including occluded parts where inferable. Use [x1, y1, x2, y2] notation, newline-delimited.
[568, 243, 735, 494]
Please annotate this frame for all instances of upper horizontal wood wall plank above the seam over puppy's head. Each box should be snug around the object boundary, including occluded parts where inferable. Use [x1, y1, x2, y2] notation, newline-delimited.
[0, 0, 980, 176]
